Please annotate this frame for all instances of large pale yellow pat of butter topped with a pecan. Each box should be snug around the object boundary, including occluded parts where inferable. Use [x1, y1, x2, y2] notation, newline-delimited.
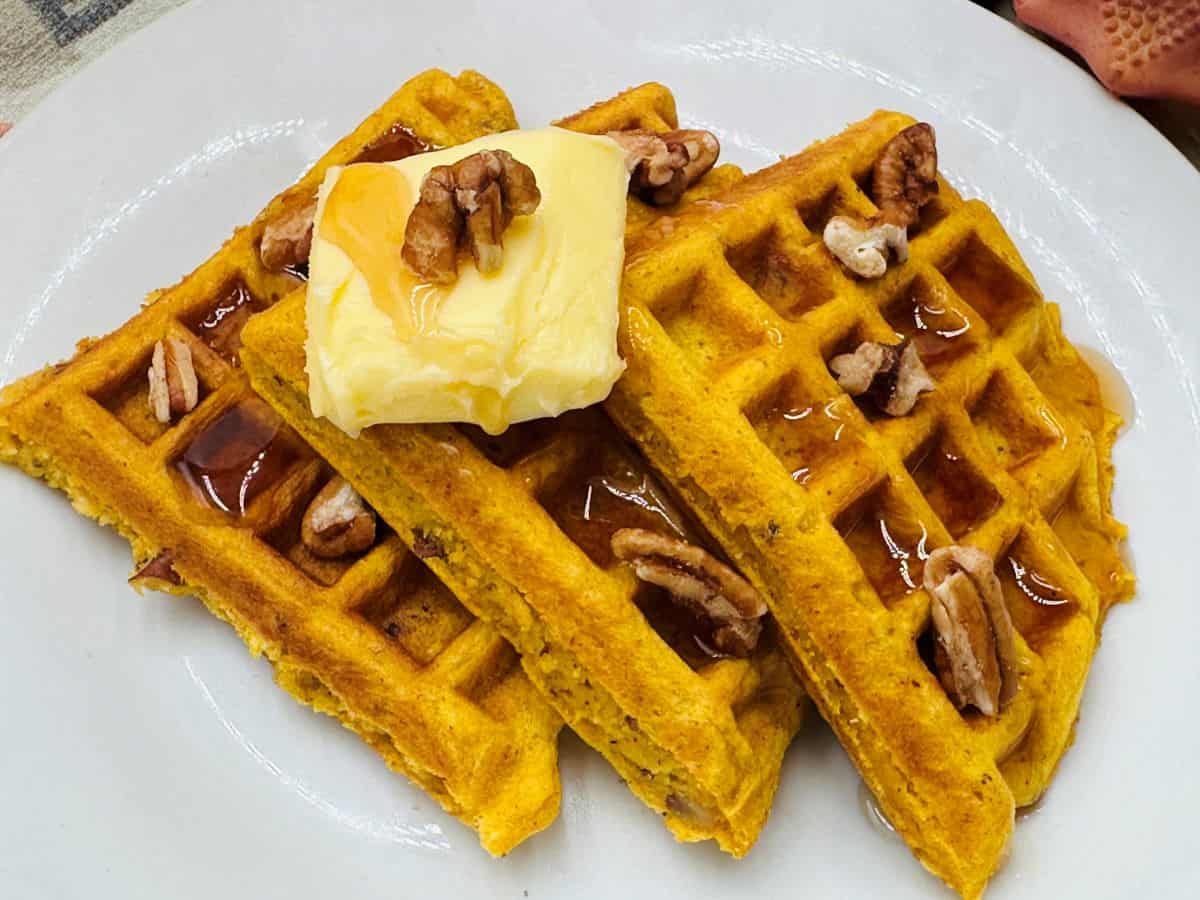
[306, 128, 629, 434]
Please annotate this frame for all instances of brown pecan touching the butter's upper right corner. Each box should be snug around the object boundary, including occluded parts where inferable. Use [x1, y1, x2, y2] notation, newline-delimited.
[608, 128, 721, 206]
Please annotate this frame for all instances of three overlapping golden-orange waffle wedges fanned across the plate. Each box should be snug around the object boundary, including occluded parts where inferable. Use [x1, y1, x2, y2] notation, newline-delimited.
[0, 71, 1133, 896]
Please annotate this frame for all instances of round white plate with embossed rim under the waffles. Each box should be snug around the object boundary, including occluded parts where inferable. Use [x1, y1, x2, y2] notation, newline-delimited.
[0, 0, 1200, 900]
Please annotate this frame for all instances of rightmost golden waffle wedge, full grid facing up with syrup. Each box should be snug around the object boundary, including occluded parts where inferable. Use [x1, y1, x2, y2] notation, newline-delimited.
[607, 113, 1133, 896]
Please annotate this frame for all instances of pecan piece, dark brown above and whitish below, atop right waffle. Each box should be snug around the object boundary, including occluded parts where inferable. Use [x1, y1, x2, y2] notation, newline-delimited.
[822, 122, 937, 278]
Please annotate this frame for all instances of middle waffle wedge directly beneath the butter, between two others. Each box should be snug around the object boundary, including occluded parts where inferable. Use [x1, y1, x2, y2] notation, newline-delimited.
[242, 84, 803, 856]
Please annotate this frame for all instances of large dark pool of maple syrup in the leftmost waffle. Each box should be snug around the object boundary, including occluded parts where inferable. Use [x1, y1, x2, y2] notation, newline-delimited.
[175, 402, 295, 516]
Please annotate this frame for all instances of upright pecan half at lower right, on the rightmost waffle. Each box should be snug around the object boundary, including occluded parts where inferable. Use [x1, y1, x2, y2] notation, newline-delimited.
[924, 545, 1020, 715]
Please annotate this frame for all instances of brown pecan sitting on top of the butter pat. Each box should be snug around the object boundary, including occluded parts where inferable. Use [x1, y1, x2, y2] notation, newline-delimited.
[401, 150, 541, 284]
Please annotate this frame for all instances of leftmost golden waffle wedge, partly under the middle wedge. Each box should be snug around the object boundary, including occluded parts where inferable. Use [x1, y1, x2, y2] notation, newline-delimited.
[0, 71, 560, 854]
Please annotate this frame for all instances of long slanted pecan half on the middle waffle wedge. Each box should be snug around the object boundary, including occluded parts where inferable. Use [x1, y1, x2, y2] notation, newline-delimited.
[612, 528, 767, 656]
